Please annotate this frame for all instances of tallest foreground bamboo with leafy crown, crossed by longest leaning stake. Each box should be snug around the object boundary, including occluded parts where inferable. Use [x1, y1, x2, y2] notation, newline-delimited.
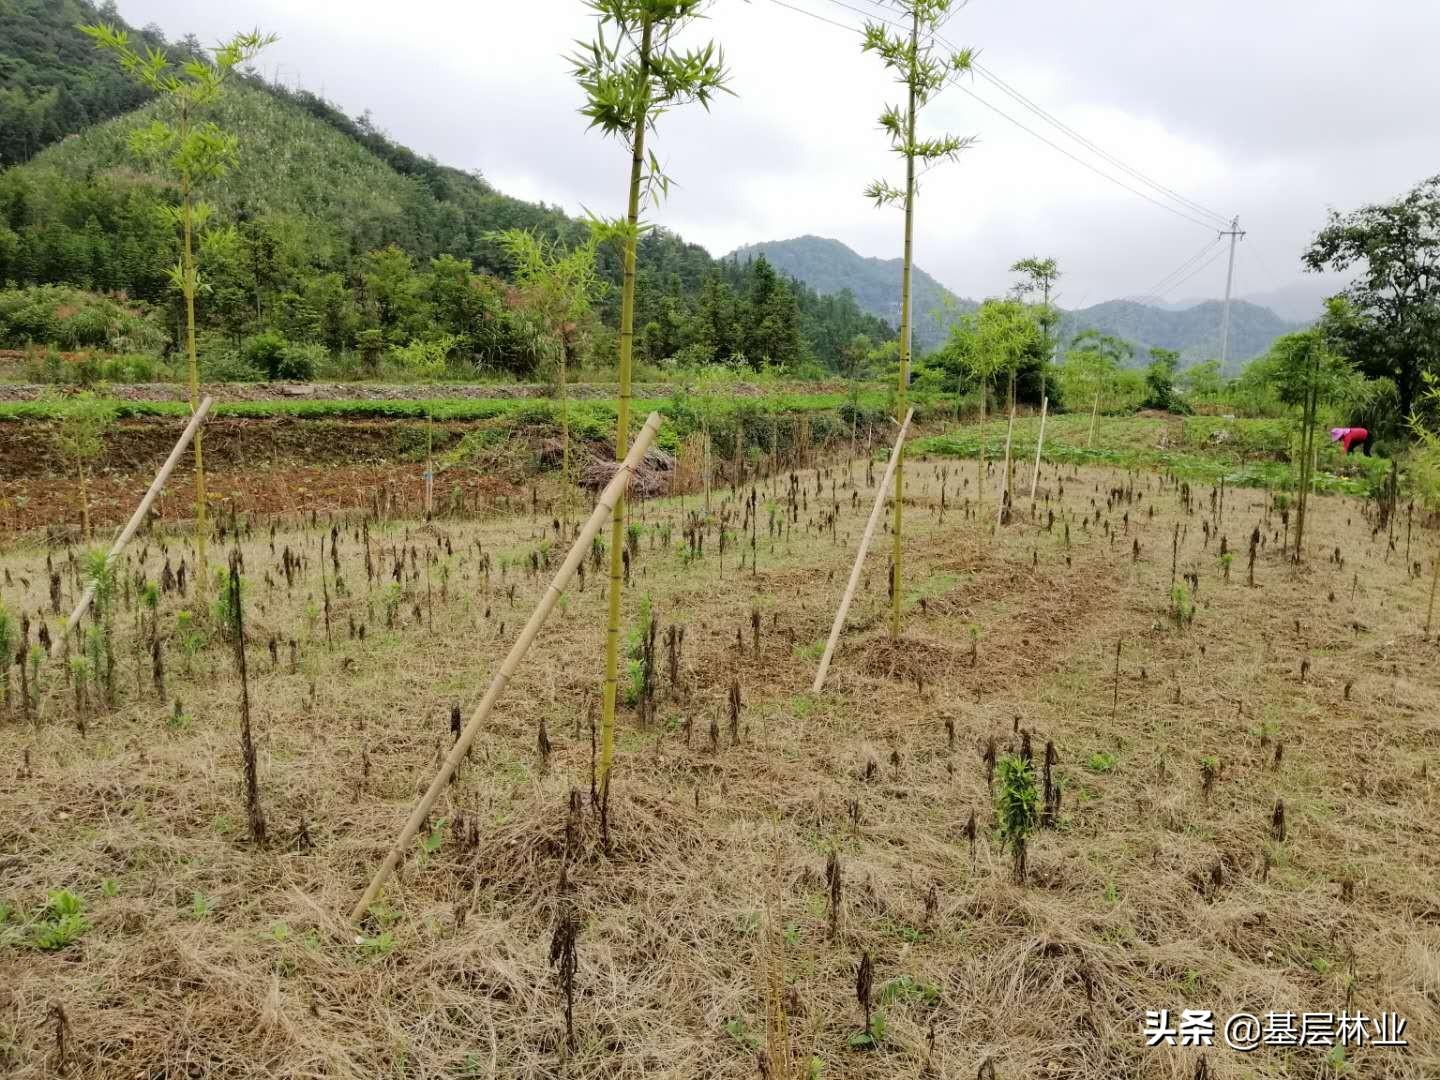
[572, 0, 729, 821]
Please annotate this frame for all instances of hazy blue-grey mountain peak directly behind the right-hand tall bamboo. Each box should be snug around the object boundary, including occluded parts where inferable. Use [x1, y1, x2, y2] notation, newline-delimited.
[726, 236, 978, 353]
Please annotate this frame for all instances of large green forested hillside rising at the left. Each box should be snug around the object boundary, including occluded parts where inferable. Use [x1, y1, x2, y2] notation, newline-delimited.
[0, 0, 888, 370]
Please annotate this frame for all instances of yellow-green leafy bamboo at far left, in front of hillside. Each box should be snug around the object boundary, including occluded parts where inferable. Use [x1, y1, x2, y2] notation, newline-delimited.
[81, 23, 275, 588]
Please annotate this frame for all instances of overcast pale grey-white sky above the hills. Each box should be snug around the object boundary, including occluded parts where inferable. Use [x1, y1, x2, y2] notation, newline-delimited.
[120, 0, 1440, 315]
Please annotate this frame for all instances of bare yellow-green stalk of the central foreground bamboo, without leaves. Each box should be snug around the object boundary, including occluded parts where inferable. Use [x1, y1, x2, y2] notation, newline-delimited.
[598, 13, 654, 806]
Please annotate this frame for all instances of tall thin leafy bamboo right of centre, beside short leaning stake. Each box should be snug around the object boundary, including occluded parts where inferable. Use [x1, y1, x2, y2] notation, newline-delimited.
[863, 0, 973, 638]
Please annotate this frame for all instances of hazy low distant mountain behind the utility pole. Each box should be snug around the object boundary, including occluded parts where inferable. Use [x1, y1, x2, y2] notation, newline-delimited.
[1060, 300, 1303, 372]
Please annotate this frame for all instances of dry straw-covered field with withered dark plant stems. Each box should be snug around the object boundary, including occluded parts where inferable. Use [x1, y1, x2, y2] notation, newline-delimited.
[0, 443, 1440, 1080]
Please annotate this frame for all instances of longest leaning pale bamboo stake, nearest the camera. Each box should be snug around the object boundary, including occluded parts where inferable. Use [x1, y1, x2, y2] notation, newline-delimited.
[350, 412, 661, 923]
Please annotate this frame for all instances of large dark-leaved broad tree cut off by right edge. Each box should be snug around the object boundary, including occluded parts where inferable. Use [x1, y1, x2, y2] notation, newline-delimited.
[1302, 176, 1440, 416]
